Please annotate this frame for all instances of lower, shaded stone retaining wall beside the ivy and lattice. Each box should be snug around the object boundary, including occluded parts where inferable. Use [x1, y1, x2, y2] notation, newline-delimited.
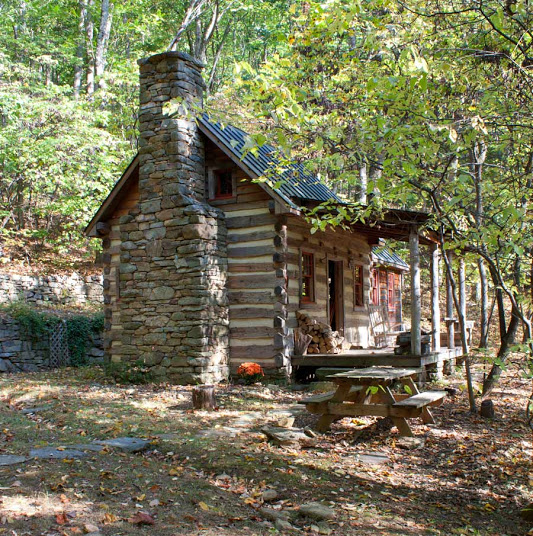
[0, 316, 104, 373]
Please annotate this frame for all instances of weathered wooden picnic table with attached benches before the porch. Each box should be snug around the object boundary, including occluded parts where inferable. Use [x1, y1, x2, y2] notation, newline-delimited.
[300, 367, 447, 436]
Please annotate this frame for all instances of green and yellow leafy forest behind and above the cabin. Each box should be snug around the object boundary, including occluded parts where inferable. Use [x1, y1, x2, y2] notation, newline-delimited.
[0, 0, 533, 394]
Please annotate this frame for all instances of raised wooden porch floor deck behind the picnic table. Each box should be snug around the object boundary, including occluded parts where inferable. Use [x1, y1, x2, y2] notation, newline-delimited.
[291, 347, 461, 368]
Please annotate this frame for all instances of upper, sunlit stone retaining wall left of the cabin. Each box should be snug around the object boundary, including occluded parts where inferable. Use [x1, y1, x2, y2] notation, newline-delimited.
[0, 272, 103, 305]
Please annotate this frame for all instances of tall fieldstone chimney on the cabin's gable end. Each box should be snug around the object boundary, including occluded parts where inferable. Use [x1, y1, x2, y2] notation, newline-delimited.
[111, 52, 229, 383]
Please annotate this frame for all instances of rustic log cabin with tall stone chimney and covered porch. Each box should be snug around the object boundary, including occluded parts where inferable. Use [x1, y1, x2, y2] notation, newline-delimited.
[86, 52, 456, 384]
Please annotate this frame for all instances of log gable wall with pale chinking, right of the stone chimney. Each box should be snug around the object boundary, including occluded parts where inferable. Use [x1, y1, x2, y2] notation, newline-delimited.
[206, 143, 283, 374]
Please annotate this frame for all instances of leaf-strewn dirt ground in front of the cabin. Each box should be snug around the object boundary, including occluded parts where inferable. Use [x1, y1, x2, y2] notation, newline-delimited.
[0, 368, 533, 536]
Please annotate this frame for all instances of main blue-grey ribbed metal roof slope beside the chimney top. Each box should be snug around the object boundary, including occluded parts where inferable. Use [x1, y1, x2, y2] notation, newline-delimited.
[198, 114, 342, 202]
